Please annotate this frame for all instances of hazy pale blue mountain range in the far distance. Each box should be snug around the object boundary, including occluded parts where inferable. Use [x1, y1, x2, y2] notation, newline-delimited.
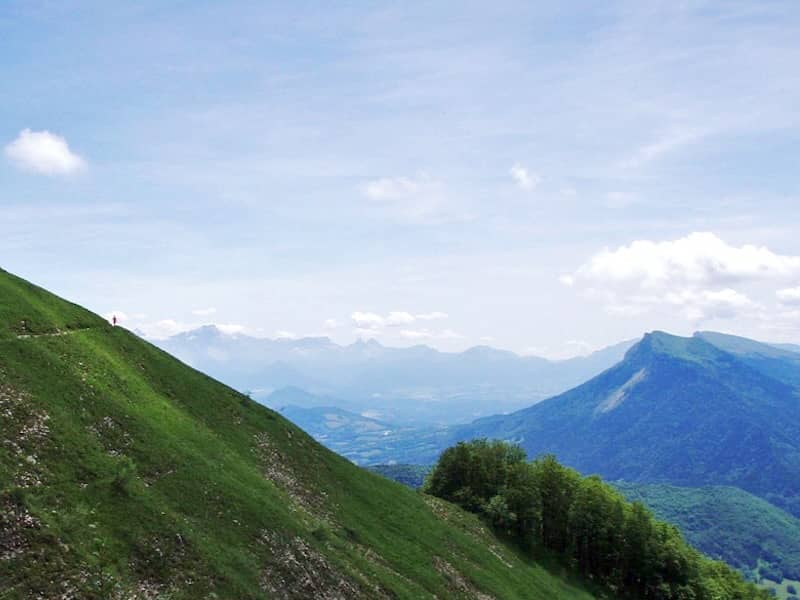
[156, 326, 633, 426]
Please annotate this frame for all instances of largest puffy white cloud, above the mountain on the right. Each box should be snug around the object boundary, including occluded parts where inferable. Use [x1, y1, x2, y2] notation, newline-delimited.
[573, 233, 800, 290]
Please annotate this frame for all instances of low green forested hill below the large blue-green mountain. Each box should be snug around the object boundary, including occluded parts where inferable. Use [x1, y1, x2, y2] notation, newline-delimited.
[616, 482, 800, 580]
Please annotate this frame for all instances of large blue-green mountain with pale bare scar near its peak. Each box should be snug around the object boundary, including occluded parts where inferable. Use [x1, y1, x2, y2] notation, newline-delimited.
[454, 332, 800, 516]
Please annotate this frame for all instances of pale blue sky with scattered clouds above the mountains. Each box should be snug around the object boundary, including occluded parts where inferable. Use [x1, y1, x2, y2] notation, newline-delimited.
[0, 0, 800, 358]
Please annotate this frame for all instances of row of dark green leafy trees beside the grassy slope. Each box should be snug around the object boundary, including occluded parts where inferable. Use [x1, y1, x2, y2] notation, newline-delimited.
[423, 440, 770, 600]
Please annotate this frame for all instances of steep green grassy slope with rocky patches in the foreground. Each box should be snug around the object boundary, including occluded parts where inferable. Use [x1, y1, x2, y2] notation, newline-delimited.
[0, 271, 590, 600]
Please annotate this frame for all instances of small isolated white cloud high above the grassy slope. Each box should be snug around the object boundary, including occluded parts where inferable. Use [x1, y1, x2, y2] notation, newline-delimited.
[5, 129, 86, 175]
